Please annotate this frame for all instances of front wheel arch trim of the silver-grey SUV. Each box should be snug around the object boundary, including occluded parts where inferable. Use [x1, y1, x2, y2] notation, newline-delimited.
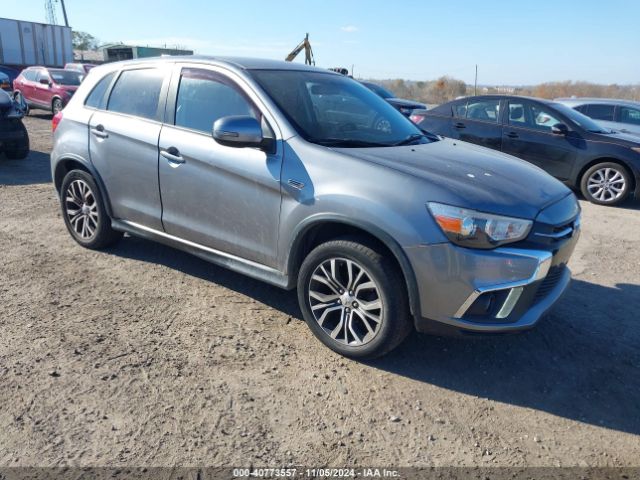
[286, 215, 420, 316]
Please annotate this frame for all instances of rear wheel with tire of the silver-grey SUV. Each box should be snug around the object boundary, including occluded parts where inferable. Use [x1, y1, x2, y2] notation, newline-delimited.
[60, 170, 122, 250]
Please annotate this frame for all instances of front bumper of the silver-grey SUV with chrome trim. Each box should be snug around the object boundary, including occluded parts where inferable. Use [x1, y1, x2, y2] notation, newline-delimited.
[405, 229, 579, 333]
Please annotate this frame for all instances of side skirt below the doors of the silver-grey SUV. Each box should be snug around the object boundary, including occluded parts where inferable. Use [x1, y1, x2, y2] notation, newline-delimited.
[111, 219, 289, 289]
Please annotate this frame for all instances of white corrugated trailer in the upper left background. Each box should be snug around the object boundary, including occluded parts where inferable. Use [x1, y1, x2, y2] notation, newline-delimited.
[0, 18, 73, 67]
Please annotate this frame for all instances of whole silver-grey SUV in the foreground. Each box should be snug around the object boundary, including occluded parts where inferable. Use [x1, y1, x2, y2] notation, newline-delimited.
[51, 57, 580, 358]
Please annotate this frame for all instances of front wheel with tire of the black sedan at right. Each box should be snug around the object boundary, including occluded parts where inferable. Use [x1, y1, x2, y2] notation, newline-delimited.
[580, 162, 631, 206]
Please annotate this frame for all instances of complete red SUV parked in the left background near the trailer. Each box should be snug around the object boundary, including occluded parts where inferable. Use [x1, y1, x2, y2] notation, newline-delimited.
[13, 67, 83, 115]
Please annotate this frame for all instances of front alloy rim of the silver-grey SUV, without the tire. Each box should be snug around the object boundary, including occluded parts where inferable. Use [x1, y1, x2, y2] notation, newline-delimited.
[308, 258, 384, 346]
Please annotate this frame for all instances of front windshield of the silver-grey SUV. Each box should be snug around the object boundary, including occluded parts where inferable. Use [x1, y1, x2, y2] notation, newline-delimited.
[252, 70, 433, 147]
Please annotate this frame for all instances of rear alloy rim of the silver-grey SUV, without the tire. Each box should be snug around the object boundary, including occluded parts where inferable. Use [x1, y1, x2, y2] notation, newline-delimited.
[64, 180, 100, 240]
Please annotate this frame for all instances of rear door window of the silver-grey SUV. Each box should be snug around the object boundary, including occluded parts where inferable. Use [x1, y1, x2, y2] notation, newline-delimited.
[107, 68, 165, 120]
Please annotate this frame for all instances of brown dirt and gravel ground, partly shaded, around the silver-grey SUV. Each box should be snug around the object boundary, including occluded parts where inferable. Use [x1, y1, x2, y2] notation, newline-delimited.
[0, 116, 640, 467]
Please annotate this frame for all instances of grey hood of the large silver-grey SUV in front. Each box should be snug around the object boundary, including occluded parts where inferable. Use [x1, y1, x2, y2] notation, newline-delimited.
[334, 135, 570, 219]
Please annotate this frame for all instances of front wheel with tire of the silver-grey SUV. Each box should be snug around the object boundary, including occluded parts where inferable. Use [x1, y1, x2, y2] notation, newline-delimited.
[298, 237, 411, 359]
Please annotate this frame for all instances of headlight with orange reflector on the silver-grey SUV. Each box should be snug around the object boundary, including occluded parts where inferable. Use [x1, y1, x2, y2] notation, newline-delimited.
[428, 202, 533, 248]
